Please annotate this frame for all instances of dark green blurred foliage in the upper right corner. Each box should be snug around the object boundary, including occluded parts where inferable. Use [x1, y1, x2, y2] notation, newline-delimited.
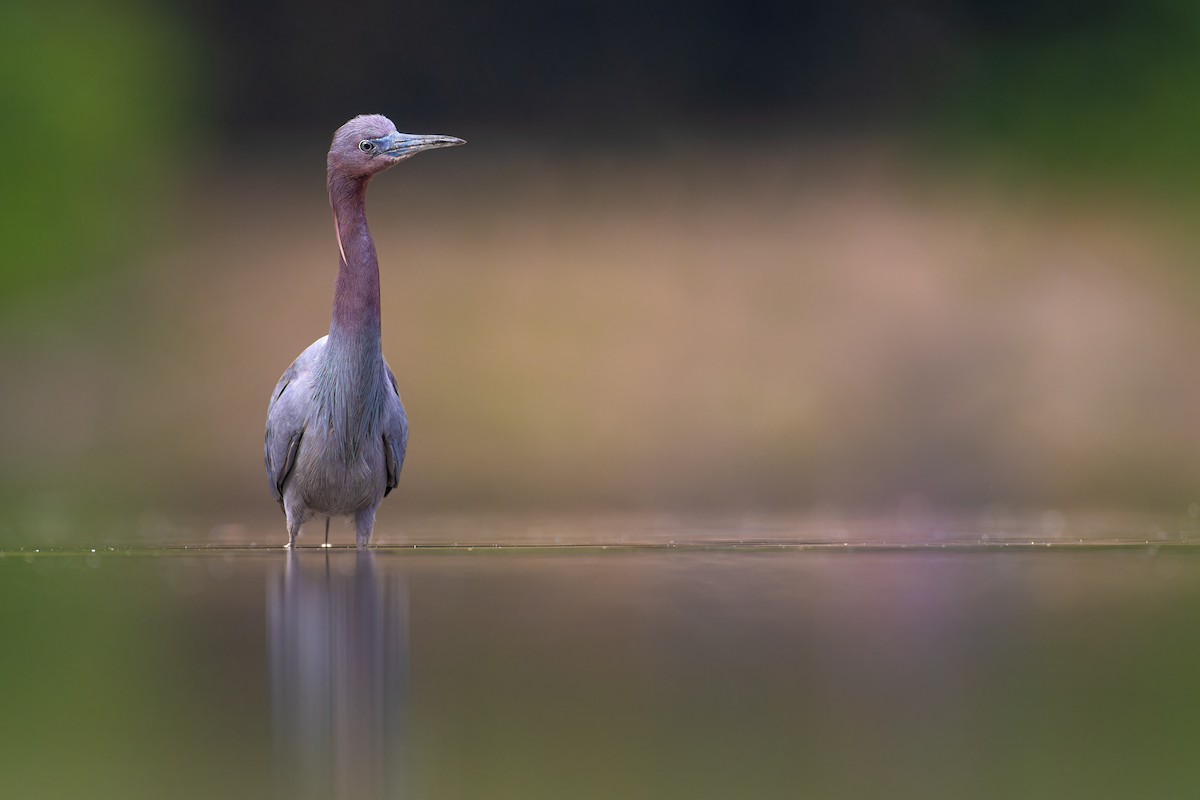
[940, 0, 1200, 192]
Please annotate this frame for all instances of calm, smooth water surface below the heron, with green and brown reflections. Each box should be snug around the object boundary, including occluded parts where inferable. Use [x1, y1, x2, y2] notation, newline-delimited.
[0, 546, 1200, 800]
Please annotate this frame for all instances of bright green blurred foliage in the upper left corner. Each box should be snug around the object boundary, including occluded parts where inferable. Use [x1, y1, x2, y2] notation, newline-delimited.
[0, 0, 192, 309]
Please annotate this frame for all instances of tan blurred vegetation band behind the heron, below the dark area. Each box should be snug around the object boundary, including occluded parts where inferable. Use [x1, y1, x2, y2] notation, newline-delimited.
[0, 142, 1200, 532]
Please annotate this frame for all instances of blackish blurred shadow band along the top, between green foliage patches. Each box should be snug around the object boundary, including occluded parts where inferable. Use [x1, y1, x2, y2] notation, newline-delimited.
[193, 0, 964, 139]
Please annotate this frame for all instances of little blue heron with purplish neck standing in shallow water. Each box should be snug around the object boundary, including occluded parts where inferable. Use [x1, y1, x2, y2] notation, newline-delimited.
[265, 114, 464, 547]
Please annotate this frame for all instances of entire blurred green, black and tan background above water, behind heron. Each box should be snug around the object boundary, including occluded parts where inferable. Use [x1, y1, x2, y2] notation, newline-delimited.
[0, 0, 1200, 543]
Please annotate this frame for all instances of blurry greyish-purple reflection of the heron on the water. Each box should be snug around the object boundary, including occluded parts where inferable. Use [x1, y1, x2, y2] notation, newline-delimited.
[268, 551, 408, 800]
